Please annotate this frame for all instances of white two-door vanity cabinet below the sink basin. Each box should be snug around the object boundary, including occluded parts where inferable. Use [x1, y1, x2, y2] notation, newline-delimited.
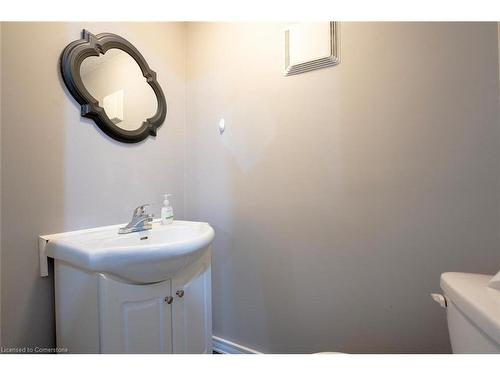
[54, 247, 212, 354]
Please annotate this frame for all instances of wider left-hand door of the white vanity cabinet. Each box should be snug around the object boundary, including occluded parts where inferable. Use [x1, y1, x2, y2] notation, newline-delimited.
[99, 274, 172, 353]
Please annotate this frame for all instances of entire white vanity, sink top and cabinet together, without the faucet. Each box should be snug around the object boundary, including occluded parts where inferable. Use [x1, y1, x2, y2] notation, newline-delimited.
[39, 221, 214, 353]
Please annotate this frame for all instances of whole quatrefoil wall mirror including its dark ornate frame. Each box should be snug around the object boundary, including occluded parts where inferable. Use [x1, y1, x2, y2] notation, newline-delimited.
[60, 30, 167, 143]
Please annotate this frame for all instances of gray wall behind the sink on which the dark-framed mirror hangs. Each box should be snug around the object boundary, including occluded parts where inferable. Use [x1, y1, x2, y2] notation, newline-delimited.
[1, 23, 186, 346]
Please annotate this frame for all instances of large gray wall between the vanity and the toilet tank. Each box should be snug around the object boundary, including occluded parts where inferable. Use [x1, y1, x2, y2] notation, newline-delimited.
[185, 23, 500, 353]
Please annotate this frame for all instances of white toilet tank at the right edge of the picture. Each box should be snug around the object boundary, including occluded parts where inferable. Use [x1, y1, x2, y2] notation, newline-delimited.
[441, 272, 500, 354]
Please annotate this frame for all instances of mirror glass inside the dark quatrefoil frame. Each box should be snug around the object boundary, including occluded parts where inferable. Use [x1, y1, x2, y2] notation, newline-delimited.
[80, 48, 157, 130]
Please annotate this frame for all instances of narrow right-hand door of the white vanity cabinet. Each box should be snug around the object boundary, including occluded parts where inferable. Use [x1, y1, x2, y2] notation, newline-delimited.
[172, 251, 212, 354]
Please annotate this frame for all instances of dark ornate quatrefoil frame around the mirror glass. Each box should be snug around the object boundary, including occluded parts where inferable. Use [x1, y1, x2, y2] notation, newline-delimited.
[60, 30, 167, 143]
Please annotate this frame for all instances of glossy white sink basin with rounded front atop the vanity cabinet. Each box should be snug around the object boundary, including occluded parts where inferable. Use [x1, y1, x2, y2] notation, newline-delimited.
[40, 220, 214, 283]
